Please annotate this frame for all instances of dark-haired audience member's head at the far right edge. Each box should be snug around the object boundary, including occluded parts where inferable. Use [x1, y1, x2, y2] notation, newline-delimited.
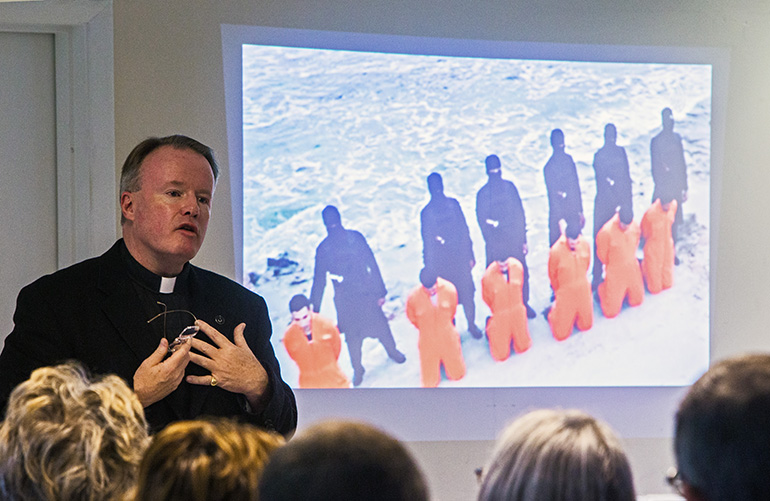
[674, 354, 770, 501]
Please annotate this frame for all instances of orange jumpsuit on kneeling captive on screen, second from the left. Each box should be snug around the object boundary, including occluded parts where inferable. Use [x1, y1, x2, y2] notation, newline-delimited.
[406, 278, 465, 388]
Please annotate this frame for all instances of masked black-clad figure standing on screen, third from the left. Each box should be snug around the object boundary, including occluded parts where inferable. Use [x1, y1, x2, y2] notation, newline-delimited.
[476, 155, 537, 318]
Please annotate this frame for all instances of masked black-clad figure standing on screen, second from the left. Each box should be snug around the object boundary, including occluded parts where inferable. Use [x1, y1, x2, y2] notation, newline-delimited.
[420, 172, 482, 339]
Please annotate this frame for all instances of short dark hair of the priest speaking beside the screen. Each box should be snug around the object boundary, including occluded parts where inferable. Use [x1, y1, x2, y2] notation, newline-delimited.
[120, 134, 219, 224]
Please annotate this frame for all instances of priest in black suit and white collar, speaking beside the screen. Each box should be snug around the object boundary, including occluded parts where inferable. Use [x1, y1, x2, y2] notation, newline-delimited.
[0, 135, 297, 435]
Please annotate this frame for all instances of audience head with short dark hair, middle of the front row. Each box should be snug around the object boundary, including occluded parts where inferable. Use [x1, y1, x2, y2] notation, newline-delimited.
[259, 421, 428, 501]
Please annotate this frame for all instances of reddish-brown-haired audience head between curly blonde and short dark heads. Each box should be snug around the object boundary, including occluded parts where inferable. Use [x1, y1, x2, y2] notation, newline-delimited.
[136, 419, 284, 501]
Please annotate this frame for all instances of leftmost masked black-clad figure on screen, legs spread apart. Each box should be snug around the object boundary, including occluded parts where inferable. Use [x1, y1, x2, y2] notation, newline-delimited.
[310, 205, 406, 386]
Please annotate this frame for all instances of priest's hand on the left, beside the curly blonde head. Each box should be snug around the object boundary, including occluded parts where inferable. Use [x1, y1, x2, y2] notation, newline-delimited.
[134, 338, 191, 407]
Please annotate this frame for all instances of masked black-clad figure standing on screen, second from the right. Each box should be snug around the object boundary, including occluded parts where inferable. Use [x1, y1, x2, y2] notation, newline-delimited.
[591, 124, 633, 290]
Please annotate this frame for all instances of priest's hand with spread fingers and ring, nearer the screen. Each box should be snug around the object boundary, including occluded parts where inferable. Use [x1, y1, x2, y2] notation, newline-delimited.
[187, 320, 268, 410]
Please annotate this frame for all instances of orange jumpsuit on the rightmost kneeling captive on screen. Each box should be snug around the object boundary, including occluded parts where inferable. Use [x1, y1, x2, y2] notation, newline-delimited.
[642, 199, 677, 294]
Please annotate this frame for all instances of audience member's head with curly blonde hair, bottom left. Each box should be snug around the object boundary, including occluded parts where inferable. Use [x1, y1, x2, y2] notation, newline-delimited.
[0, 363, 148, 501]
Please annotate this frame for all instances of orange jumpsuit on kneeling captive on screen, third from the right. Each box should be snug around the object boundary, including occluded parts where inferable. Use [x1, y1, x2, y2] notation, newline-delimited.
[548, 235, 594, 341]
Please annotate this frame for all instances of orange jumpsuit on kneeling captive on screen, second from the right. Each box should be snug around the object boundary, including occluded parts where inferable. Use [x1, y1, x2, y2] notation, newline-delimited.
[596, 214, 644, 318]
